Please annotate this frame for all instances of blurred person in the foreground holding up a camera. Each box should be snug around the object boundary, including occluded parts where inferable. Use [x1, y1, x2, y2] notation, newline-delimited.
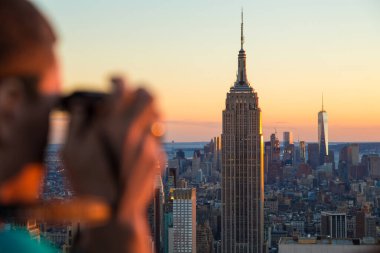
[0, 0, 164, 253]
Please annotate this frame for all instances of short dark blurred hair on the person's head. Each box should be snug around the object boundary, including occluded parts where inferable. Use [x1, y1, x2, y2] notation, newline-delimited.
[0, 0, 56, 78]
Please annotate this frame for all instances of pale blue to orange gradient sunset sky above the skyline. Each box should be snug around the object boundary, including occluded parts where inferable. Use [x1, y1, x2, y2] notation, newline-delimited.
[35, 0, 380, 141]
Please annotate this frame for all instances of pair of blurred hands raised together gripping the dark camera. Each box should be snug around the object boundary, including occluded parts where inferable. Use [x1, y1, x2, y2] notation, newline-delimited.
[64, 79, 162, 213]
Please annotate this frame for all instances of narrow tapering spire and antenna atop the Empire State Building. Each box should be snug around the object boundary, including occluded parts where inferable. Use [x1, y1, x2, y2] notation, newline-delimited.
[234, 11, 250, 88]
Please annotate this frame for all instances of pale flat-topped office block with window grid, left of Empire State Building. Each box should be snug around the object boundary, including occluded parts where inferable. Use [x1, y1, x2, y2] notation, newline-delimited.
[169, 188, 197, 253]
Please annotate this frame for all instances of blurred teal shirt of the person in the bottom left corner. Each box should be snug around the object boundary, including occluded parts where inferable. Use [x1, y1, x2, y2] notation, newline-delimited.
[0, 230, 58, 253]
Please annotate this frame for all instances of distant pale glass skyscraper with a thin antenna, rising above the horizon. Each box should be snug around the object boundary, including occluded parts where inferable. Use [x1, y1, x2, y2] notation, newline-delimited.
[318, 96, 329, 165]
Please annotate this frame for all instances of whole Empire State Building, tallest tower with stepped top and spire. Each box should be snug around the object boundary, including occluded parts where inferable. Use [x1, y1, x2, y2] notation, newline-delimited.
[222, 14, 264, 253]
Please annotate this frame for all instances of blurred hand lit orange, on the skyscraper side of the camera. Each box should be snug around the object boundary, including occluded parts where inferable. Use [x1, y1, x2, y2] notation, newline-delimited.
[108, 79, 165, 221]
